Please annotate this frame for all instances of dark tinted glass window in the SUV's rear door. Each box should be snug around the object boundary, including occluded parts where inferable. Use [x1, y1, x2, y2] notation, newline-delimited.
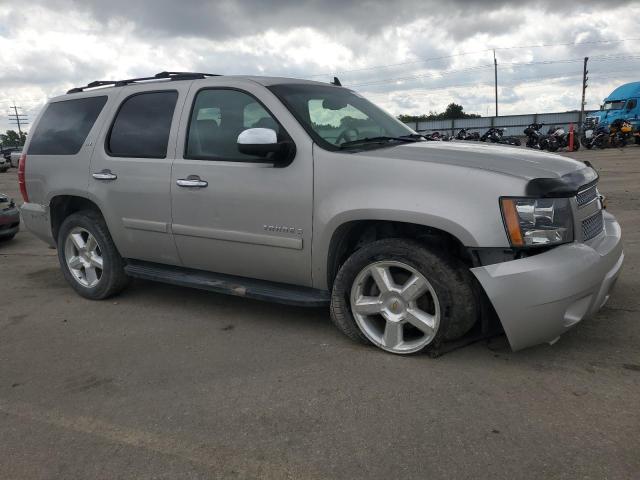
[108, 92, 178, 158]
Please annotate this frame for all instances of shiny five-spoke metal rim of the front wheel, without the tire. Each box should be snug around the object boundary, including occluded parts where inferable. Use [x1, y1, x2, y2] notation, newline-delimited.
[351, 261, 440, 353]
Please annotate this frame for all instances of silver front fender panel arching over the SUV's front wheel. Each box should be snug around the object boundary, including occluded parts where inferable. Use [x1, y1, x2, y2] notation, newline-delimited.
[312, 148, 526, 288]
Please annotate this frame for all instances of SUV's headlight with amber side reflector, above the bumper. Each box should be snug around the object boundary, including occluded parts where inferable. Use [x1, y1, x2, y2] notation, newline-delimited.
[500, 198, 573, 247]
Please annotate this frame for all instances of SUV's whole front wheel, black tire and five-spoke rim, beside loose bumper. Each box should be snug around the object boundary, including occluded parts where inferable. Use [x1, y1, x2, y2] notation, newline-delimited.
[331, 239, 478, 354]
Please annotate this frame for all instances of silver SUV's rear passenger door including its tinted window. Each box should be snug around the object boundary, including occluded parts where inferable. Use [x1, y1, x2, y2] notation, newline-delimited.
[89, 81, 191, 265]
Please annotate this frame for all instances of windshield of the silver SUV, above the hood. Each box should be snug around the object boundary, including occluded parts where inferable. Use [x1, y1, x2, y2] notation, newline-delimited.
[269, 84, 416, 150]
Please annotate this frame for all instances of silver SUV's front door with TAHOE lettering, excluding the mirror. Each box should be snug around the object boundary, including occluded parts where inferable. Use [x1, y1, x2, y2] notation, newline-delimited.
[171, 81, 313, 286]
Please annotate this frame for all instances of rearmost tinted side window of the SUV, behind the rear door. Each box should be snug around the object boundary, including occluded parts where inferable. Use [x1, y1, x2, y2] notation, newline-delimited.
[29, 96, 107, 155]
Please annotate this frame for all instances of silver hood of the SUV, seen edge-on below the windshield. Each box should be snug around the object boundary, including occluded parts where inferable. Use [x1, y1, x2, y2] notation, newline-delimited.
[356, 141, 588, 180]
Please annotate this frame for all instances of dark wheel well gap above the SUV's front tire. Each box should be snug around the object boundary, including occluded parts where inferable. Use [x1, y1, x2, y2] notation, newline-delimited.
[327, 220, 472, 289]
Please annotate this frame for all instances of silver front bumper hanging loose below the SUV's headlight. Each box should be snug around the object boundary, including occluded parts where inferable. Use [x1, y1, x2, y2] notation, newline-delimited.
[471, 211, 624, 350]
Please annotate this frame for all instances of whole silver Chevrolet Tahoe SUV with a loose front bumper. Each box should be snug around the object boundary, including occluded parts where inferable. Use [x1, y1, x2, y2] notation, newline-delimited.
[19, 72, 624, 354]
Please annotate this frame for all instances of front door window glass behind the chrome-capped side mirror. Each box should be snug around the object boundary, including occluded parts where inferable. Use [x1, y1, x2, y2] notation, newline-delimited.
[185, 89, 283, 162]
